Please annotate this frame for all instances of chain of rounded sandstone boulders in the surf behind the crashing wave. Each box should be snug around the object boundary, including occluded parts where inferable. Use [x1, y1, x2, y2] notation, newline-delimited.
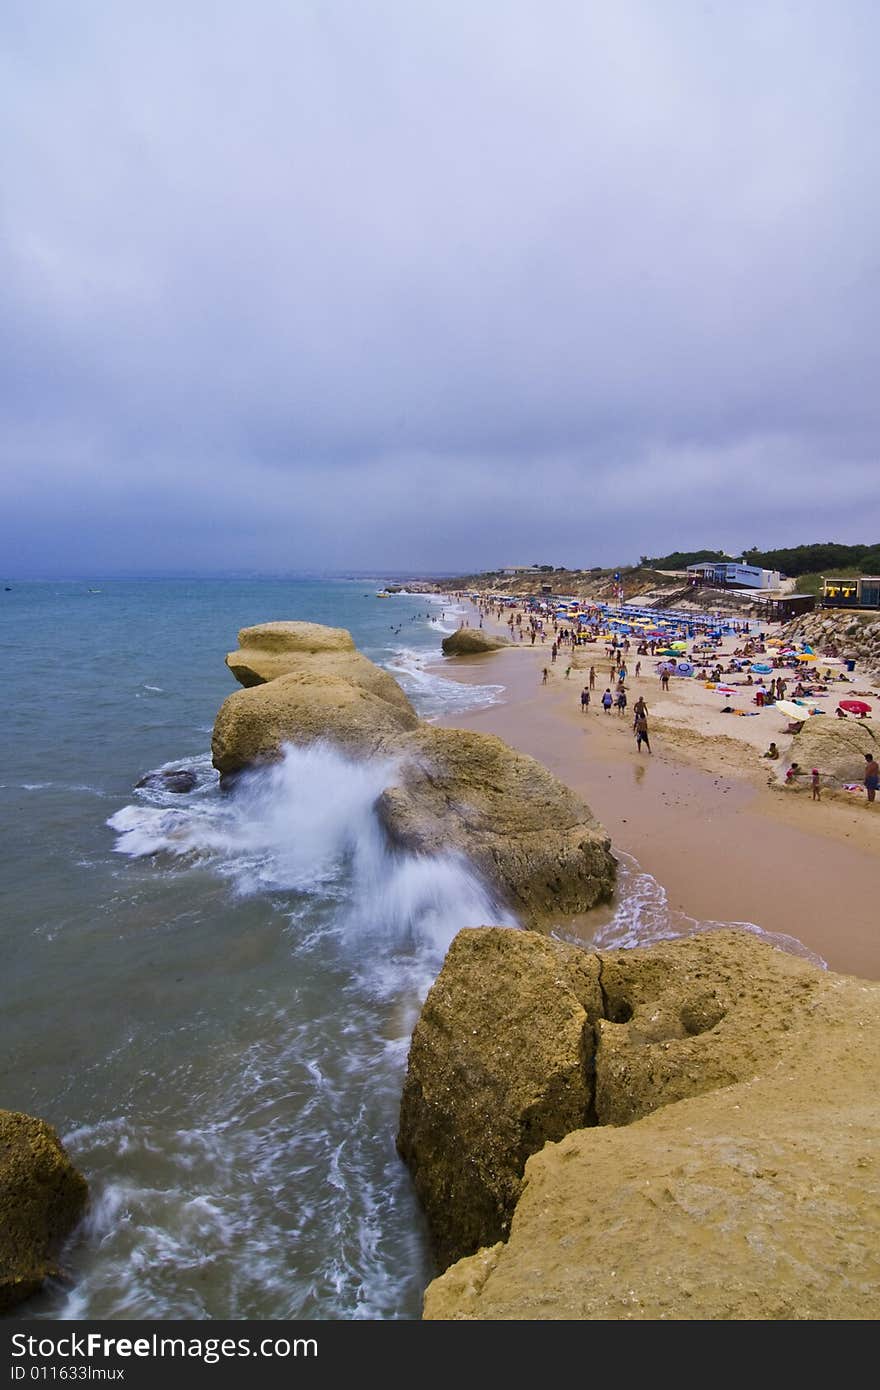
[211, 623, 616, 927]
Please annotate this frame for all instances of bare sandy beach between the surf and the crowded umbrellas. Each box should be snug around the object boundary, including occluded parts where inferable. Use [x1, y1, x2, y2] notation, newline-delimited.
[437, 606, 880, 979]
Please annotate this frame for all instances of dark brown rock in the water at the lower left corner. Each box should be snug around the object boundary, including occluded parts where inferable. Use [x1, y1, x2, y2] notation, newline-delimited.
[0, 1111, 88, 1312]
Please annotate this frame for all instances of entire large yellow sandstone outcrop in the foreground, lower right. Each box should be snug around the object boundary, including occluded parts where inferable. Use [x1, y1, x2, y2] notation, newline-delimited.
[399, 929, 880, 1321]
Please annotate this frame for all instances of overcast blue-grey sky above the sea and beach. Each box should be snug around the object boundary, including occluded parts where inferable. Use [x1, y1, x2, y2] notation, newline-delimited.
[0, 0, 880, 575]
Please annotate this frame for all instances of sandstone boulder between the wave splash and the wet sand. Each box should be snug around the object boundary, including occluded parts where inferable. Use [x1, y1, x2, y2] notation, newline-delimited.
[377, 724, 616, 926]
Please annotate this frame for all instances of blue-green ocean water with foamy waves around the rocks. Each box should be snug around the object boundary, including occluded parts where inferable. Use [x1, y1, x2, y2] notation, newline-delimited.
[0, 580, 823, 1319]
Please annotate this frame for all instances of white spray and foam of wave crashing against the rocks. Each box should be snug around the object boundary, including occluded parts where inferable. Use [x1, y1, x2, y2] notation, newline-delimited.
[107, 742, 513, 962]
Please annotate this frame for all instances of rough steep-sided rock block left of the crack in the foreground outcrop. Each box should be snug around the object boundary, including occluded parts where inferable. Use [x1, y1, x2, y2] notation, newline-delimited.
[398, 927, 602, 1266]
